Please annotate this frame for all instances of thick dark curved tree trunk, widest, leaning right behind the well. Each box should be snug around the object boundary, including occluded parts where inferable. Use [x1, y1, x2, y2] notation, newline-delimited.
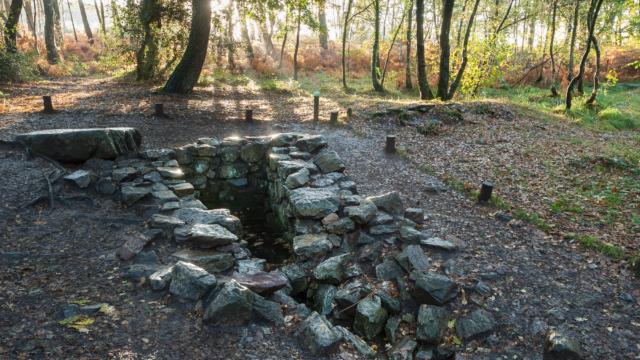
[164, 0, 211, 94]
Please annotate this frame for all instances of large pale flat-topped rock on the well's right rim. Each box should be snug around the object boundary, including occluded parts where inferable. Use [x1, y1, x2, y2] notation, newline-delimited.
[289, 187, 340, 219]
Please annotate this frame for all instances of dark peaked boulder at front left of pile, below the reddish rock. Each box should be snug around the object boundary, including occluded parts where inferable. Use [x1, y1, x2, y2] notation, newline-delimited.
[203, 280, 255, 325]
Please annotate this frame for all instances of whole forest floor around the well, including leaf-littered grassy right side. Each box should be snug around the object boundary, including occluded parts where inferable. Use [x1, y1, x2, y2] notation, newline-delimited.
[0, 78, 640, 359]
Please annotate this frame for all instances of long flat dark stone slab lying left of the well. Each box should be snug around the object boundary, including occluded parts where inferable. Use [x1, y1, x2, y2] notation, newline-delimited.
[16, 127, 142, 162]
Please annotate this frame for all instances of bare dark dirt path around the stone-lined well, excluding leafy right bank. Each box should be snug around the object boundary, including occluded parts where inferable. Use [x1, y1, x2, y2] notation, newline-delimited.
[0, 79, 640, 359]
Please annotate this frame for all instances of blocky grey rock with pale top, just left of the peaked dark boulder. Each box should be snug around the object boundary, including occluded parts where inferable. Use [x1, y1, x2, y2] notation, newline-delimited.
[169, 261, 216, 301]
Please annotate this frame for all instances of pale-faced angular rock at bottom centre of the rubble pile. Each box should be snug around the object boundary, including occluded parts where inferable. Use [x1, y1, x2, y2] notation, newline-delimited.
[298, 312, 342, 355]
